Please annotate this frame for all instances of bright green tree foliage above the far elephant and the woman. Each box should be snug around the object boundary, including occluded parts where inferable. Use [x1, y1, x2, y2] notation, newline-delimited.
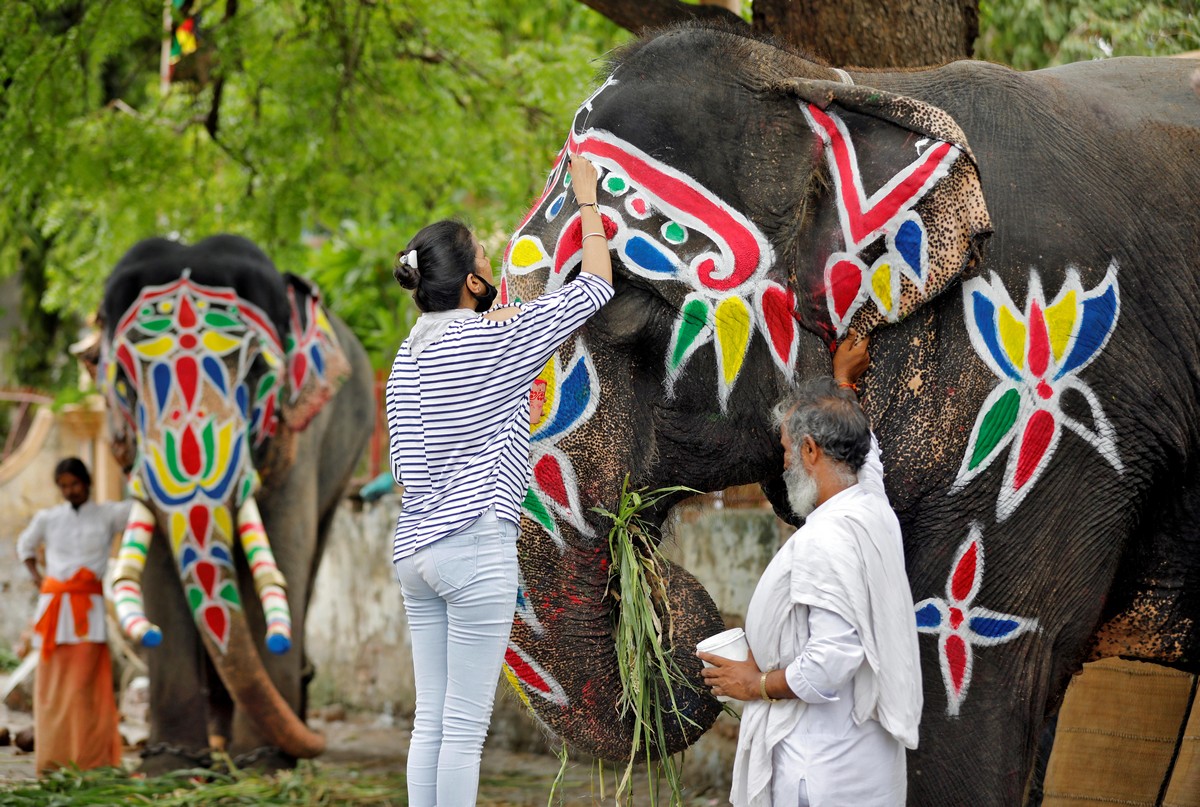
[0, 0, 628, 383]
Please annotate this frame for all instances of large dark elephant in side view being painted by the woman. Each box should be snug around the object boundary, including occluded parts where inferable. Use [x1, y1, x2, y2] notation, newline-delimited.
[500, 26, 1200, 805]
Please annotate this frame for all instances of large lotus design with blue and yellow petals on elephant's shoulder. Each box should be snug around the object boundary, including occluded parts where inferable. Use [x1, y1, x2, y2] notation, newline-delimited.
[952, 263, 1123, 521]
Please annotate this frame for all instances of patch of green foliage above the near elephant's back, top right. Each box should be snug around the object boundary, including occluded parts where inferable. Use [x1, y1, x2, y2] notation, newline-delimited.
[976, 0, 1200, 70]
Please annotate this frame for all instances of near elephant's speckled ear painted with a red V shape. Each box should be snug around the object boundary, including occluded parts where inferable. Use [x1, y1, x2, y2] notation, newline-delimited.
[782, 79, 991, 336]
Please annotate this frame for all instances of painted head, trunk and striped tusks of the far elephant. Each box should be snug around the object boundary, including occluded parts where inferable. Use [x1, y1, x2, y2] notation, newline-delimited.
[100, 235, 348, 757]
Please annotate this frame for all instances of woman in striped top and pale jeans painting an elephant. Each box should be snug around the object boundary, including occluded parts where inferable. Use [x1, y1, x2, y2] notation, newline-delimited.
[388, 153, 612, 807]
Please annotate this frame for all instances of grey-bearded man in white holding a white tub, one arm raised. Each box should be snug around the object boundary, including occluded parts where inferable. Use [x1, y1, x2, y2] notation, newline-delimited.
[700, 331, 922, 807]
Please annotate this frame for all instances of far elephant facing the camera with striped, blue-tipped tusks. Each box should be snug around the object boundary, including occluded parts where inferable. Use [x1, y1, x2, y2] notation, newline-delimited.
[98, 235, 374, 772]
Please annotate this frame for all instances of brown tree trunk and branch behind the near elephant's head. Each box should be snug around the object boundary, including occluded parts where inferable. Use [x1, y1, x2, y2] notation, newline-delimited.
[580, 0, 979, 67]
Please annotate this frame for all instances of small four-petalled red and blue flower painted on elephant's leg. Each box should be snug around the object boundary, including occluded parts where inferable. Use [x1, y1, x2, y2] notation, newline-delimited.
[914, 525, 1038, 716]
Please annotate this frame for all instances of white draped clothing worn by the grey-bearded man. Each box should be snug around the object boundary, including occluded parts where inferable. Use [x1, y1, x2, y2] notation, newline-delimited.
[731, 440, 922, 807]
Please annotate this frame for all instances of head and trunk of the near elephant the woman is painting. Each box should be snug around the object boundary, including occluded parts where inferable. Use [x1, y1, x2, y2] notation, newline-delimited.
[500, 28, 990, 759]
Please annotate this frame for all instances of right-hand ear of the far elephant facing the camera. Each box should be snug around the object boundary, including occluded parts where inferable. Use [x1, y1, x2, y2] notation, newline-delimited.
[280, 273, 350, 431]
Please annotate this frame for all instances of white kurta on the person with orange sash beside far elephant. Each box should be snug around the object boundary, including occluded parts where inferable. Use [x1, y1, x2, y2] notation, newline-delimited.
[17, 501, 132, 646]
